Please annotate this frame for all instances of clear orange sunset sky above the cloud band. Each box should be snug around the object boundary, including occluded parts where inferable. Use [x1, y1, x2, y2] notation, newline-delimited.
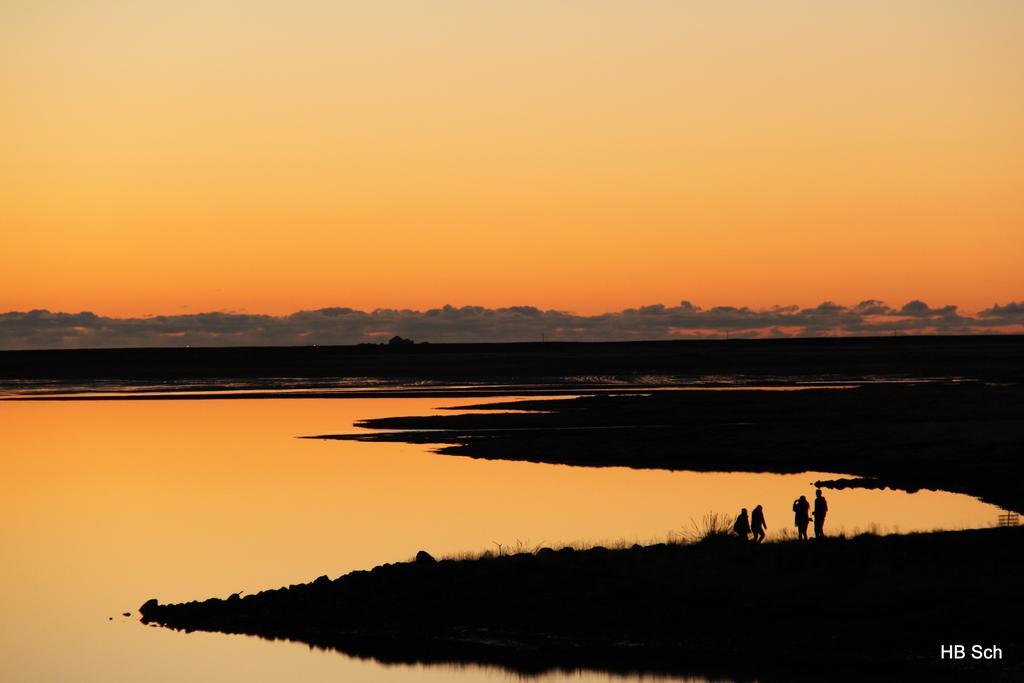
[0, 0, 1024, 316]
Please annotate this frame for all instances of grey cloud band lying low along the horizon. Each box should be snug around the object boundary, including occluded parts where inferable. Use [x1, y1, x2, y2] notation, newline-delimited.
[0, 299, 1024, 350]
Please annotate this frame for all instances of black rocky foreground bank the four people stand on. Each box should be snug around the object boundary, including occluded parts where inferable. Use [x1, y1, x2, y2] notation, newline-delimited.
[141, 528, 1024, 680]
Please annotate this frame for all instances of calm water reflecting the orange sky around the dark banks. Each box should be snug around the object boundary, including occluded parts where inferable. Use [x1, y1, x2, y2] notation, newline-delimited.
[0, 397, 998, 682]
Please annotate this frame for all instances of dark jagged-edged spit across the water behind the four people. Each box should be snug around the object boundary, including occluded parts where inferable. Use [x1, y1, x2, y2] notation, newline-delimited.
[312, 382, 1024, 511]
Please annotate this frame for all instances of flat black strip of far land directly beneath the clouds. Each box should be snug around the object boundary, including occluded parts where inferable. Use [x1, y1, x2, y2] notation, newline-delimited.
[0, 335, 1024, 383]
